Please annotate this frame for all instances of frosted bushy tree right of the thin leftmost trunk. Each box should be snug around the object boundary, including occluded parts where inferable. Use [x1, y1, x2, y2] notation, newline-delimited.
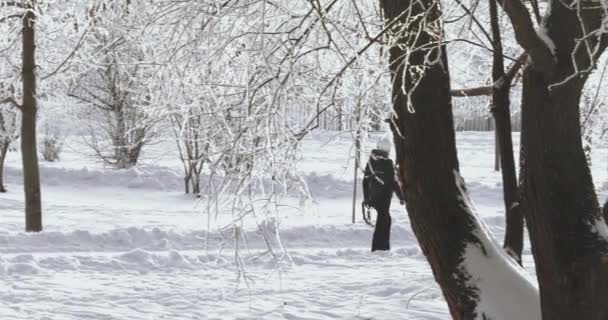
[69, 0, 160, 169]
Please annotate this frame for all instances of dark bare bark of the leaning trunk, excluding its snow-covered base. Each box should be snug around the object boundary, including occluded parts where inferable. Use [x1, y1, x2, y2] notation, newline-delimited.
[383, 0, 478, 319]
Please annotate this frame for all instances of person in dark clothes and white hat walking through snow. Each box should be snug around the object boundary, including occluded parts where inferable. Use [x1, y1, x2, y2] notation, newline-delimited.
[363, 134, 405, 252]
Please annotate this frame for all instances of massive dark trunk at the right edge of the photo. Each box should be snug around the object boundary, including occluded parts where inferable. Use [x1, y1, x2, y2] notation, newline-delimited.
[521, 1, 608, 320]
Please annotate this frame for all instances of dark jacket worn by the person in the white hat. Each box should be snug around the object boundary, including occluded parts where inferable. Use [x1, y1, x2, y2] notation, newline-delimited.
[363, 149, 404, 210]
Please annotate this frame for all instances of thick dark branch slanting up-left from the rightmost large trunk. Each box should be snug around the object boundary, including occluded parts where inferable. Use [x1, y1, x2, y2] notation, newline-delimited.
[498, 0, 555, 79]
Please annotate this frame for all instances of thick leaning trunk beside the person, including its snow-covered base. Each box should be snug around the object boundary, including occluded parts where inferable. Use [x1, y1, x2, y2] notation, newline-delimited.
[383, 0, 540, 320]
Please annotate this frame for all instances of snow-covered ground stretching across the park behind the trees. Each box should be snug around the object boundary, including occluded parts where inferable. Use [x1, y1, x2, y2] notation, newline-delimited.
[0, 132, 608, 320]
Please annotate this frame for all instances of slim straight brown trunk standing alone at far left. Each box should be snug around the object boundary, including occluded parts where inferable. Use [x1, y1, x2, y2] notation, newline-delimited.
[21, 1, 42, 232]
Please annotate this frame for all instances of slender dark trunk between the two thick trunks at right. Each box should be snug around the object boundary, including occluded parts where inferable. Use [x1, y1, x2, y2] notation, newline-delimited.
[490, 0, 524, 265]
